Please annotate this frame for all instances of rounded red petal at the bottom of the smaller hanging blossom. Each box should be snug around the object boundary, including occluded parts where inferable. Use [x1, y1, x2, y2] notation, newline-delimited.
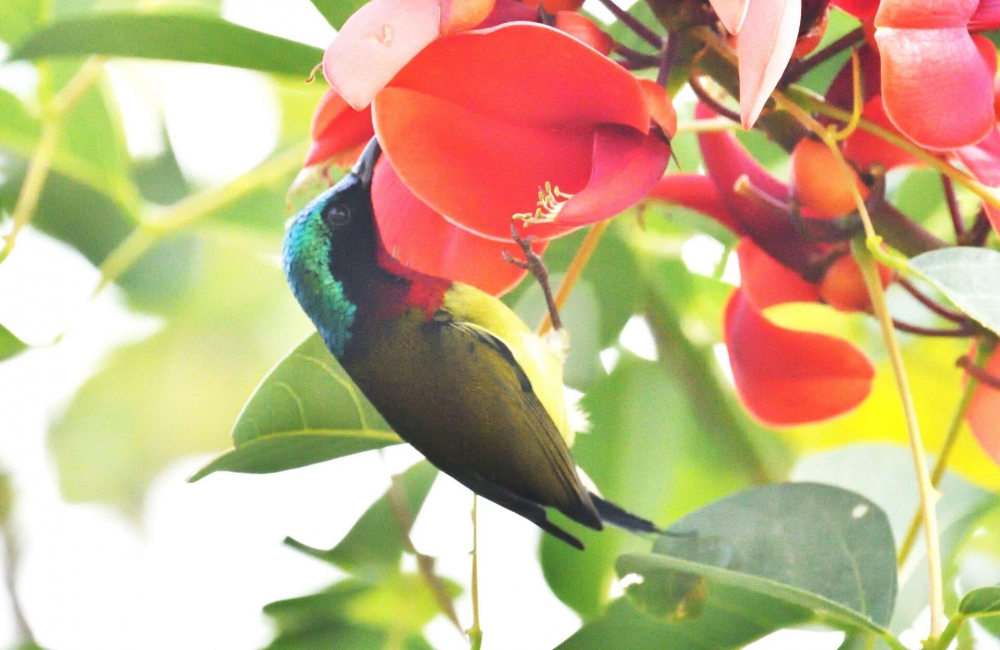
[725, 290, 875, 426]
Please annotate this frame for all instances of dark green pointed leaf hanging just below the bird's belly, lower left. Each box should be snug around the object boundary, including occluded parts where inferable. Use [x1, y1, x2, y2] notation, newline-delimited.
[285, 461, 438, 579]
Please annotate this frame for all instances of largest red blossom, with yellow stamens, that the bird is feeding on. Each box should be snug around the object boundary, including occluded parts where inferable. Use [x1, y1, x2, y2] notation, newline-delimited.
[310, 15, 676, 293]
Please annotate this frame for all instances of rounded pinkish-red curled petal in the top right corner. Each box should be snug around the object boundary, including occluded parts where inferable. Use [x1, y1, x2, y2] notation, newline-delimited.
[875, 25, 995, 150]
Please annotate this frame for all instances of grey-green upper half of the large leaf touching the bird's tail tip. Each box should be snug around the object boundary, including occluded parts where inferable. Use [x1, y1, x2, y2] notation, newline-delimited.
[653, 483, 896, 625]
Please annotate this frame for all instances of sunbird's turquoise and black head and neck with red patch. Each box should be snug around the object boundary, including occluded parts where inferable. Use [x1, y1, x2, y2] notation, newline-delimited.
[284, 180, 451, 358]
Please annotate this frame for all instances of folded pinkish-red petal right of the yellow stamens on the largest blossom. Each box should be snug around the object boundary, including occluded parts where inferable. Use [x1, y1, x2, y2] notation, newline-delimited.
[558, 124, 670, 226]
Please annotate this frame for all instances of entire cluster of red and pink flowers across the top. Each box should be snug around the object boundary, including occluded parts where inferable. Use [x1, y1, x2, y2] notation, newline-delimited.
[306, 0, 1000, 460]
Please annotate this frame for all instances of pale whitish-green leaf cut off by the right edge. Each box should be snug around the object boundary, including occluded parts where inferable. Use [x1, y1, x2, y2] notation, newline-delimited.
[909, 246, 1000, 333]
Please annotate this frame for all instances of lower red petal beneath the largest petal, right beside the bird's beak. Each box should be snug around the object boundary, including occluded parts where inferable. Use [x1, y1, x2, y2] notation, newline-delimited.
[372, 158, 545, 295]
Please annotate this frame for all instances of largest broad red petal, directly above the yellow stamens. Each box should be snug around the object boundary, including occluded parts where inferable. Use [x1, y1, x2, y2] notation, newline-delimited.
[374, 23, 648, 241]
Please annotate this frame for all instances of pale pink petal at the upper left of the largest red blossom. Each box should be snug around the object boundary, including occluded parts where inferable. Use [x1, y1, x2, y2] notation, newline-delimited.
[323, 0, 441, 111]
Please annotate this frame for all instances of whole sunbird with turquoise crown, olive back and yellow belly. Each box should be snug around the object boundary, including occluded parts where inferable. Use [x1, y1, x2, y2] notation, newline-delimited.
[283, 139, 660, 550]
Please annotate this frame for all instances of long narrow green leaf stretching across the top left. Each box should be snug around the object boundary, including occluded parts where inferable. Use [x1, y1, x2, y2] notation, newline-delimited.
[11, 12, 323, 78]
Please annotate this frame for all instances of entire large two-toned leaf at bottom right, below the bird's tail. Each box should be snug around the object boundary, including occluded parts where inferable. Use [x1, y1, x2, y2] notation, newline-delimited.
[560, 483, 901, 650]
